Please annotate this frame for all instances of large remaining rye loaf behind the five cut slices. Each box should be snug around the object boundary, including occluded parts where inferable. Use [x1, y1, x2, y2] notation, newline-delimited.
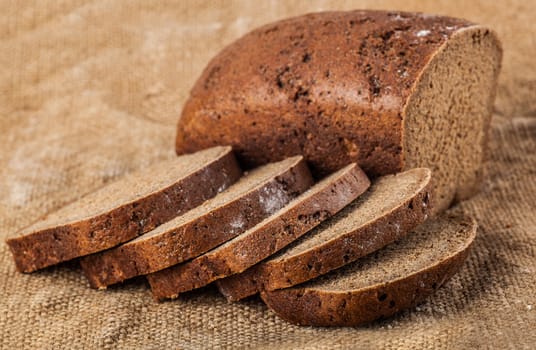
[176, 11, 502, 211]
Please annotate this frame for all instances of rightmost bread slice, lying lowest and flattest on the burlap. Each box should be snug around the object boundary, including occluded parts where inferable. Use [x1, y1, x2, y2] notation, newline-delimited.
[261, 216, 477, 326]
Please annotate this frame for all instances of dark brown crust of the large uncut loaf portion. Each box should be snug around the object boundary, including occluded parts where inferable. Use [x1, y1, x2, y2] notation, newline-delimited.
[176, 11, 471, 177]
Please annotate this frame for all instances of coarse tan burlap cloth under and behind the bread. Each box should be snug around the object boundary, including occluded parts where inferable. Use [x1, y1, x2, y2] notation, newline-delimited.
[0, 0, 536, 349]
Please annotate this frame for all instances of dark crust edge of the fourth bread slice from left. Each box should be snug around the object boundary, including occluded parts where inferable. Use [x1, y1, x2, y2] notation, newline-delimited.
[216, 170, 433, 301]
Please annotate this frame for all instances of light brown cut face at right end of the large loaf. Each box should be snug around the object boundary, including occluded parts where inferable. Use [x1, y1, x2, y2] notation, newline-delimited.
[403, 26, 502, 213]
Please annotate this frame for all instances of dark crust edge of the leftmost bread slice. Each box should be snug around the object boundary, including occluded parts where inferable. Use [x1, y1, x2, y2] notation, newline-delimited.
[7, 147, 242, 272]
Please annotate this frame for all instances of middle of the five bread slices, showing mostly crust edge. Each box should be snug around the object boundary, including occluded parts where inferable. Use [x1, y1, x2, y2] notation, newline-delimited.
[147, 163, 370, 300]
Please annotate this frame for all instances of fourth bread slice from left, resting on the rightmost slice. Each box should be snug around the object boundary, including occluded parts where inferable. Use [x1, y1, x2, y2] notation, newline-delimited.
[217, 168, 431, 301]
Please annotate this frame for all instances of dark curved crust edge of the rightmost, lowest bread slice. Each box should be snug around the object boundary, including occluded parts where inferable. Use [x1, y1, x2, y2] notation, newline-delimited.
[261, 215, 476, 326]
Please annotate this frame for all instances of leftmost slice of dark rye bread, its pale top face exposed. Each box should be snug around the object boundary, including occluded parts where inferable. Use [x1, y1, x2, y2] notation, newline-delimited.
[7, 147, 242, 272]
